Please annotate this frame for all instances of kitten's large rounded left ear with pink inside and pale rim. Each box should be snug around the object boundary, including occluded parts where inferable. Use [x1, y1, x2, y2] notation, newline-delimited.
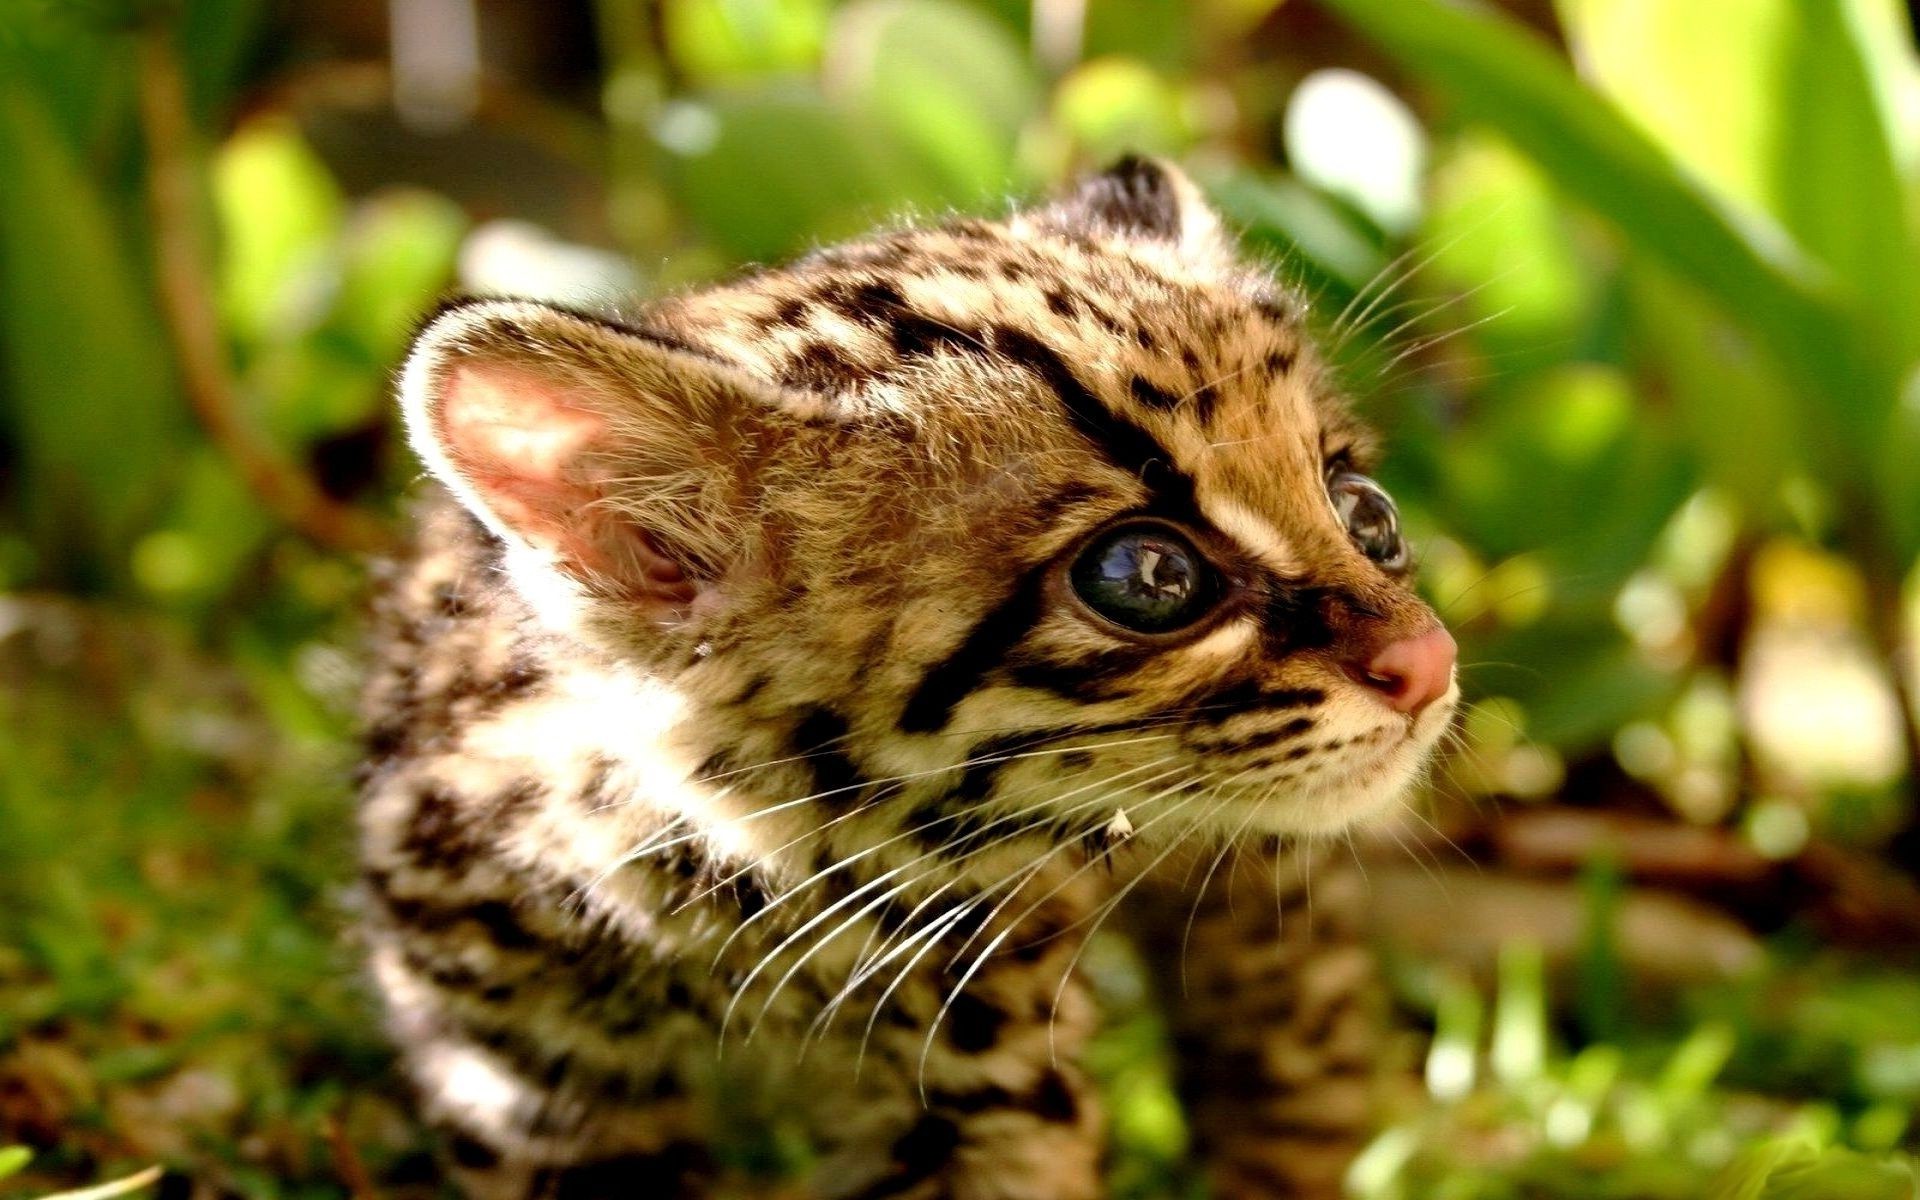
[399, 300, 778, 612]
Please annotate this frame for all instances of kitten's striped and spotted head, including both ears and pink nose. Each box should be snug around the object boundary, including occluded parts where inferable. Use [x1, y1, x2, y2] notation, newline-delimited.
[401, 159, 1457, 845]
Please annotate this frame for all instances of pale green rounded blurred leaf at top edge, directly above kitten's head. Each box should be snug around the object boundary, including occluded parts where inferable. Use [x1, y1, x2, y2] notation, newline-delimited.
[826, 0, 1041, 204]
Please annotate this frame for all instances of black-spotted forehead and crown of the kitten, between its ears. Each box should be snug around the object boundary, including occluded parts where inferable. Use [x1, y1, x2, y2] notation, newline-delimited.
[662, 217, 1357, 513]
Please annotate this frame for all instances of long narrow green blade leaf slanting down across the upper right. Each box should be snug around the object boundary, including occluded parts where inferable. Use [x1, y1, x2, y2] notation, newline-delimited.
[1329, 0, 1899, 486]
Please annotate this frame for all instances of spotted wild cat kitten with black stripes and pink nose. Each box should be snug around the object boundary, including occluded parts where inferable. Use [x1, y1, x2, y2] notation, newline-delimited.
[363, 159, 1455, 1200]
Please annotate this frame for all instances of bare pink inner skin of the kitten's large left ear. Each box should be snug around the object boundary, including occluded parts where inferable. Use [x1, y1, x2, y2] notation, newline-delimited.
[434, 363, 693, 607]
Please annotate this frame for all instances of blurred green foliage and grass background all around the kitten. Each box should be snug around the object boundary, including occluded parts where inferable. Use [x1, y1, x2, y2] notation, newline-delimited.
[0, 0, 1920, 1200]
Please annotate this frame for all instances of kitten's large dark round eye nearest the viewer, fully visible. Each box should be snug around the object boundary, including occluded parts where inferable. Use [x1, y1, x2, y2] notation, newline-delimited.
[1069, 524, 1219, 634]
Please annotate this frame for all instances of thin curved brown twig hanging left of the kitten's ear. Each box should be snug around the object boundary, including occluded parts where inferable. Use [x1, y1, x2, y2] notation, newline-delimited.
[138, 21, 394, 553]
